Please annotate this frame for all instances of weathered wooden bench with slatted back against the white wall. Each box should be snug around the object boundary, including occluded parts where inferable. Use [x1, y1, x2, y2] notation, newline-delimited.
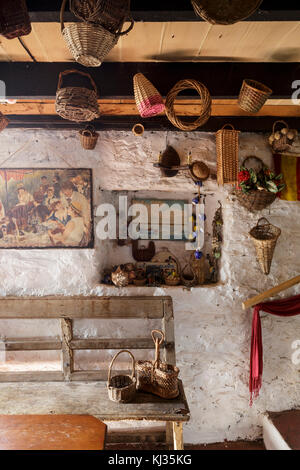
[0, 296, 189, 450]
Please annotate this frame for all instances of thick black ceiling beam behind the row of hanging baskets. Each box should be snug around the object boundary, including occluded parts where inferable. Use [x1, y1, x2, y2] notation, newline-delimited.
[0, 62, 300, 99]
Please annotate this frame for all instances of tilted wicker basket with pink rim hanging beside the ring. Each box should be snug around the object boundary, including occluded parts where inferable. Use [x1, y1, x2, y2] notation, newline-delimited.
[133, 73, 165, 118]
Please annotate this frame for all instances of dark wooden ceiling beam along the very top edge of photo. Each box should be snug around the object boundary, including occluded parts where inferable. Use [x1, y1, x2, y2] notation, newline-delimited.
[27, 0, 300, 22]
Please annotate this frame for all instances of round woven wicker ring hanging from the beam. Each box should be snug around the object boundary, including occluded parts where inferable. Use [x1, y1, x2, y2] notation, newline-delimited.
[166, 79, 211, 131]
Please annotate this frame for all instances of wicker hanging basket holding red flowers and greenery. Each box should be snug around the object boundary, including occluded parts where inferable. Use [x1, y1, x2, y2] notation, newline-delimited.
[234, 157, 277, 212]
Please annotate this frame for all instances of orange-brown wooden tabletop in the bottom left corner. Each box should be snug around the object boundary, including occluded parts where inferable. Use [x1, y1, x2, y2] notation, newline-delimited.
[0, 415, 106, 450]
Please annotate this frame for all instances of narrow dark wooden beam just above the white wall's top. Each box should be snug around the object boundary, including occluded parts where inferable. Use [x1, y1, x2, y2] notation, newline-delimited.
[8, 115, 300, 133]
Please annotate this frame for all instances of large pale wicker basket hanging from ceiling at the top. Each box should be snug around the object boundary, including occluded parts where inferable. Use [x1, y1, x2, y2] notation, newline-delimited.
[60, 0, 133, 67]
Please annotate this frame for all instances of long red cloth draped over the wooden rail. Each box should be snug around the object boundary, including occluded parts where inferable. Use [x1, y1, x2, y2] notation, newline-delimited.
[249, 295, 300, 406]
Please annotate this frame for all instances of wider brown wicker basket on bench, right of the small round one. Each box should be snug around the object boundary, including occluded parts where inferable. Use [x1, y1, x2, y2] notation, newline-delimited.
[136, 330, 179, 399]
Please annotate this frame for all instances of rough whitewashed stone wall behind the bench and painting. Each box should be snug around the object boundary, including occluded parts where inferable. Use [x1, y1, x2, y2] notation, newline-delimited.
[0, 129, 300, 443]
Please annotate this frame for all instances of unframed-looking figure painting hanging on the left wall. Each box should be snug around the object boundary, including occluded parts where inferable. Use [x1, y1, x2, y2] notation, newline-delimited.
[0, 168, 94, 249]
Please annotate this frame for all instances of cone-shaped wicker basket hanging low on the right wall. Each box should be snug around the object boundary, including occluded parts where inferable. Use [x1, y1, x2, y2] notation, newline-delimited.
[249, 217, 281, 274]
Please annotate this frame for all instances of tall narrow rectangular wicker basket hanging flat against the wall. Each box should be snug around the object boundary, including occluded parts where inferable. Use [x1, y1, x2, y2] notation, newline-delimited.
[216, 124, 240, 185]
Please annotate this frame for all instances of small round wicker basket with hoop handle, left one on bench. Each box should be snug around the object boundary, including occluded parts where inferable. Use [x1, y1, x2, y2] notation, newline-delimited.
[107, 349, 136, 403]
